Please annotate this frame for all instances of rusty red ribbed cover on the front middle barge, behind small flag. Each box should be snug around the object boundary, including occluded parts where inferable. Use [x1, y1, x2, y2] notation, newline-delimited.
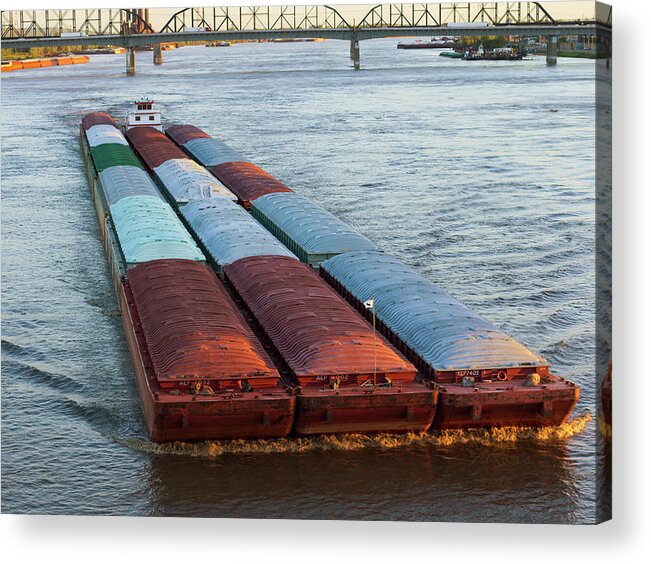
[224, 256, 416, 385]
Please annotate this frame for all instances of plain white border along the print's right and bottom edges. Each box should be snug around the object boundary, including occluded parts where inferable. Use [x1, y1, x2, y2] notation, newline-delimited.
[0, 0, 651, 564]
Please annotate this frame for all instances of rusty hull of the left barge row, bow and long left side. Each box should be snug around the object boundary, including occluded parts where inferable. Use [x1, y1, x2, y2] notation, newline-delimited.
[81, 128, 296, 442]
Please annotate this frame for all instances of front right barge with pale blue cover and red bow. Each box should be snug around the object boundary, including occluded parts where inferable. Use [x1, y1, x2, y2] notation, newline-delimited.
[321, 251, 579, 429]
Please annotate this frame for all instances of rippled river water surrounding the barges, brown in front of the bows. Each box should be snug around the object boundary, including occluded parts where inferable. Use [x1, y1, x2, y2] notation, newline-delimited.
[1, 39, 610, 523]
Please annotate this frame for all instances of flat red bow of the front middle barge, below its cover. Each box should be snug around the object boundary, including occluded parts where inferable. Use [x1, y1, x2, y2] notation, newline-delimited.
[294, 383, 438, 435]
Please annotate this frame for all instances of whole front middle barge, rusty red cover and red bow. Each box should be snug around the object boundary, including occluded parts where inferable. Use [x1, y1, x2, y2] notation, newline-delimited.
[224, 256, 438, 435]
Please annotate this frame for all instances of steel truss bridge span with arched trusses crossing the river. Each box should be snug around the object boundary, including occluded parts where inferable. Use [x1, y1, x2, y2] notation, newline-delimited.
[2, 2, 611, 49]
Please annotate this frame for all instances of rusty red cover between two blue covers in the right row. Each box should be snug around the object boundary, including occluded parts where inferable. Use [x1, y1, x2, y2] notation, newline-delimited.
[208, 162, 293, 206]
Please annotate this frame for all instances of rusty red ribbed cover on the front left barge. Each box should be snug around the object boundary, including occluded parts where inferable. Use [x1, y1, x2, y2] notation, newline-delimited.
[129, 259, 279, 386]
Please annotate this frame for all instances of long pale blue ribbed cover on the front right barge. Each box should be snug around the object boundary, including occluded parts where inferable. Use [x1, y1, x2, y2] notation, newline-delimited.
[321, 252, 548, 371]
